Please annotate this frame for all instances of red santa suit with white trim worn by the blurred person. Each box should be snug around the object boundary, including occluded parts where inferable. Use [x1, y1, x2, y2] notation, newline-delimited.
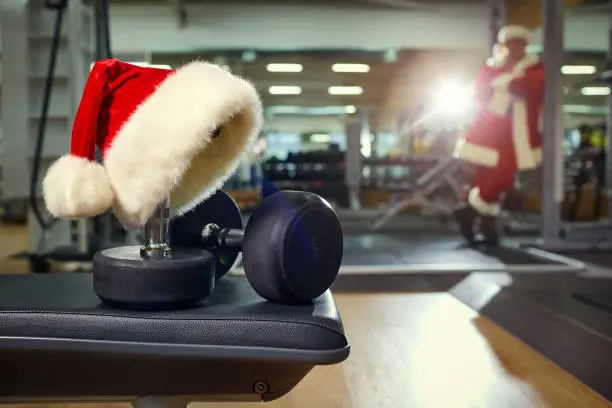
[454, 55, 544, 216]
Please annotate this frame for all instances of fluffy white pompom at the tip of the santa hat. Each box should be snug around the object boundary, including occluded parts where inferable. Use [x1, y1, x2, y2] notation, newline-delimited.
[42, 156, 114, 219]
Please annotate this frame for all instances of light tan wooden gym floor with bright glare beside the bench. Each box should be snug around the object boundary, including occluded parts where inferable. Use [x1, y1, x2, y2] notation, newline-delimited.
[0, 226, 612, 408]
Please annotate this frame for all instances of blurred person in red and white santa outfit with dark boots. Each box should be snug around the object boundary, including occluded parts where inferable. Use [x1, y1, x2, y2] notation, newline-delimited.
[454, 26, 544, 245]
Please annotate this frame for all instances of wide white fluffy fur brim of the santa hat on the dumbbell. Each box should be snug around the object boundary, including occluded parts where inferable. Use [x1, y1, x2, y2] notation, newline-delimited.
[104, 62, 262, 228]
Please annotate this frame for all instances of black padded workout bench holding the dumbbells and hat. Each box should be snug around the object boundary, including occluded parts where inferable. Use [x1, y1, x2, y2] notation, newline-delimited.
[0, 274, 349, 401]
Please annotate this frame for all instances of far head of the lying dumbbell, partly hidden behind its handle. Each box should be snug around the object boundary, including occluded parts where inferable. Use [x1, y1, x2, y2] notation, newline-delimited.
[170, 190, 244, 279]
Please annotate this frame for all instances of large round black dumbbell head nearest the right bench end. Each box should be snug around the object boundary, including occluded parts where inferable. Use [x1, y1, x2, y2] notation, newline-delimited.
[242, 191, 343, 304]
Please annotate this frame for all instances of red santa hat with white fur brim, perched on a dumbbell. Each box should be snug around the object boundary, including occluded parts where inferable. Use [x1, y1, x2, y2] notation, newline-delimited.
[43, 59, 262, 228]
